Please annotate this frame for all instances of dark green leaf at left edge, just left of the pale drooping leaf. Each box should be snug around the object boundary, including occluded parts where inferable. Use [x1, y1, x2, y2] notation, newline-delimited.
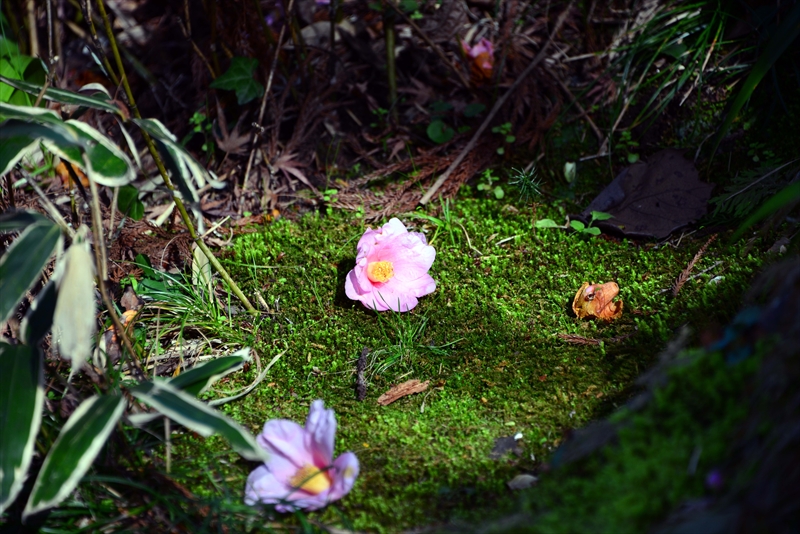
[0, 220, 61, 323]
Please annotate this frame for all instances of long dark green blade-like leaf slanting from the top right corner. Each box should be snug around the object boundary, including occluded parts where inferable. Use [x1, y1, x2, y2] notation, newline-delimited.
[711, 3, 800, 159]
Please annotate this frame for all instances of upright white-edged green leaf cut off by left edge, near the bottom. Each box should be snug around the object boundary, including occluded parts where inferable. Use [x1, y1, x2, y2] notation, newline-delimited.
[0, 342, 44, 514]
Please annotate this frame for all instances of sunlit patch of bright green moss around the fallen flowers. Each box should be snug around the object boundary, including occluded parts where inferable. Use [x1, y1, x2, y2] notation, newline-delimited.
[152, 192, 763, 532]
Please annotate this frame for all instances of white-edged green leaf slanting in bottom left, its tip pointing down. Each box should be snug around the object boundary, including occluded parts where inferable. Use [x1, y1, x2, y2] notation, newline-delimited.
[22, 395, 125, 519]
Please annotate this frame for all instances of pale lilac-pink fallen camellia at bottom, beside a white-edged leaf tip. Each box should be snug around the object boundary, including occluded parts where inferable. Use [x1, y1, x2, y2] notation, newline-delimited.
[244, 399, 358, 512]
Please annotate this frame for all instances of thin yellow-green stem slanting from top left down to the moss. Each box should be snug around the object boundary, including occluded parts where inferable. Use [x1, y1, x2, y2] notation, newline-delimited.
[97, 0, 258, 315]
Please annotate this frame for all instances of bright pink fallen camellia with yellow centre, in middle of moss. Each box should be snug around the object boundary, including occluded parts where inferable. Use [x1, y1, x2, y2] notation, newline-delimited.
[344, 219, 436, 312]
